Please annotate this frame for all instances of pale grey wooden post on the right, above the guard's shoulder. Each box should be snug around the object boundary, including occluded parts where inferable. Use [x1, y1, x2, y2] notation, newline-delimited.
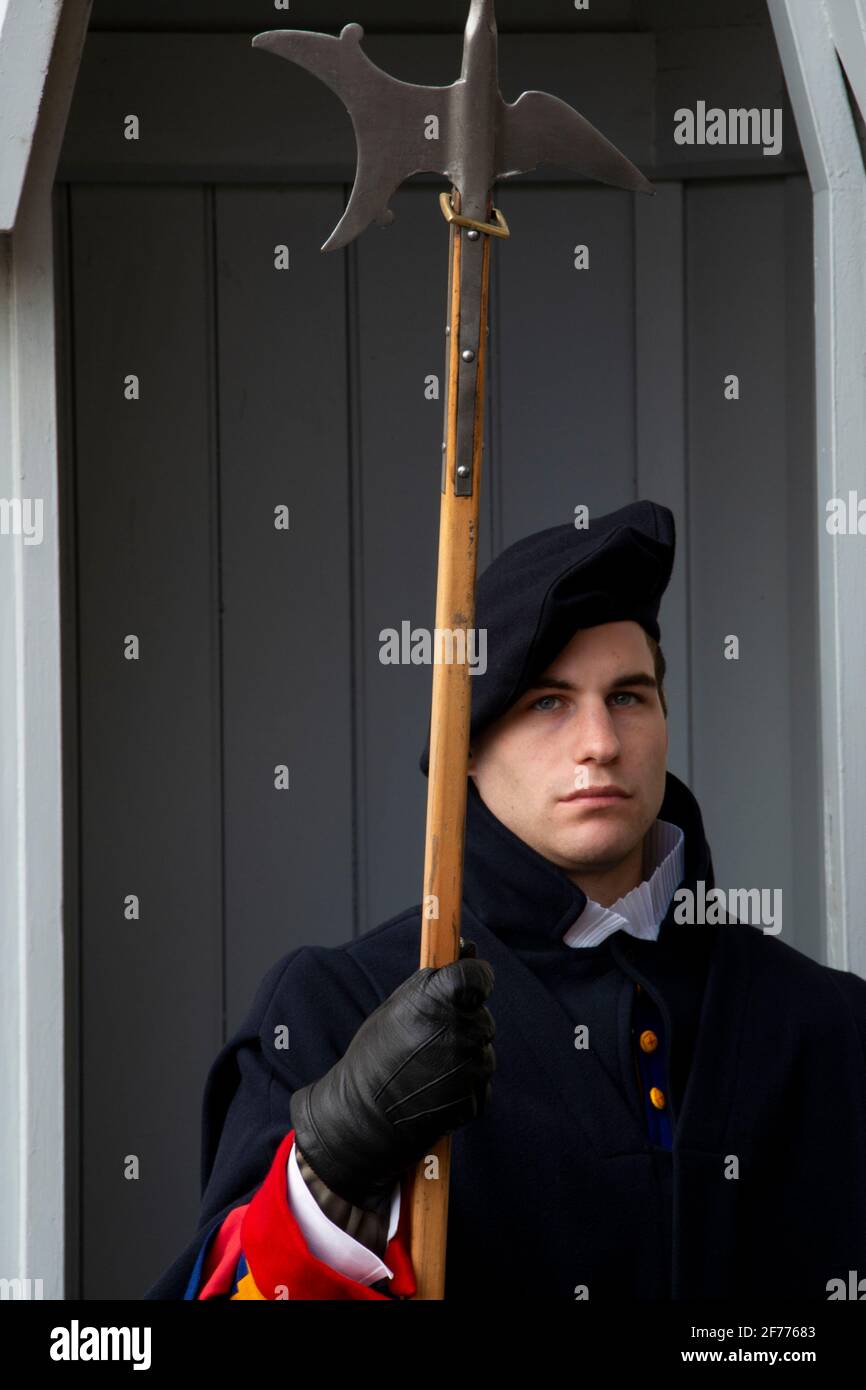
[767, 0, 866, 976]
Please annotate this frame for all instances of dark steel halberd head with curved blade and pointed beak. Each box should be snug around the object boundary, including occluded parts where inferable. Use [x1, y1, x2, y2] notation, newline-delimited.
[252, 0, 655, 252]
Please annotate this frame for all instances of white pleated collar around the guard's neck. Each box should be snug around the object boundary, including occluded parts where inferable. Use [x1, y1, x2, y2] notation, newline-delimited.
[563, 820, 685, 947]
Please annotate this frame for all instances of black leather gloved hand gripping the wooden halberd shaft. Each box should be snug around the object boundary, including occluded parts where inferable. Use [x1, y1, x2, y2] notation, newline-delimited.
[291, 942, 496, 1211]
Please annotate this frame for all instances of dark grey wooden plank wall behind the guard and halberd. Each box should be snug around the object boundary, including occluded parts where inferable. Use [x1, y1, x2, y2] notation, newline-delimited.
[57, 2, 822, 1298]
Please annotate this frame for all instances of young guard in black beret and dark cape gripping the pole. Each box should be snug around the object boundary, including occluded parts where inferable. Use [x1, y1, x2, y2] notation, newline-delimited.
[146, 502, 866, 1301]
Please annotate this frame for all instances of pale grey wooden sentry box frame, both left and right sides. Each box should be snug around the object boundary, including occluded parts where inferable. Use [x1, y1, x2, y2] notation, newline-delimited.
[0, 0, 866, 1298]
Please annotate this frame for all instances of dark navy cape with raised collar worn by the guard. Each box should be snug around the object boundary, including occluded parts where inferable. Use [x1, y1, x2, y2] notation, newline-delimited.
[143, 771, 866, 1301]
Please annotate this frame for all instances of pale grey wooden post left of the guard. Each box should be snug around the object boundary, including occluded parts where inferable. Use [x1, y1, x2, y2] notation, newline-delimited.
[0, 0, 90, 1298]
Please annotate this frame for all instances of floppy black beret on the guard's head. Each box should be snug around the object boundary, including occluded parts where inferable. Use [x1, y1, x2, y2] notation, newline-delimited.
[420, 502, 676, 777]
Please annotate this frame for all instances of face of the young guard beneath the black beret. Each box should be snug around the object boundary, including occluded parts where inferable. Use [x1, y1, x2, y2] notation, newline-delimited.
[468, 621, 667, 881]
